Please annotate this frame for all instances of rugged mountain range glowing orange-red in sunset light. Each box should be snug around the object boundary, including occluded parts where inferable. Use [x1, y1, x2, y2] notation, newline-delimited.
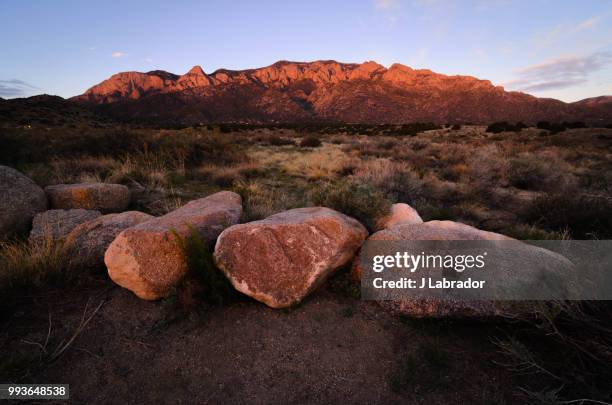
[7, 60, 612, 124]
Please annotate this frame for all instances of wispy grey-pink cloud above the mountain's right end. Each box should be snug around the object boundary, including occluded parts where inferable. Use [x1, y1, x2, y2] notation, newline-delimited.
[506, 52, 612, 91]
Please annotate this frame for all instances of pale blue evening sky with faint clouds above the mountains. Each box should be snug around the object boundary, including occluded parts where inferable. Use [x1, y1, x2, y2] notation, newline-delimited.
[0, 0, 612, 102]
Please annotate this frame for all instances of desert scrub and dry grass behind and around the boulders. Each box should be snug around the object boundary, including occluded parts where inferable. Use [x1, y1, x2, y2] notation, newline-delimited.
[0, 122, 612, 403]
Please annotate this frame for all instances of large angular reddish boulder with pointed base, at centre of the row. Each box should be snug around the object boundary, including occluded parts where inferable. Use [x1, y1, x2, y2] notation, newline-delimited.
[214, 207, 368, 308]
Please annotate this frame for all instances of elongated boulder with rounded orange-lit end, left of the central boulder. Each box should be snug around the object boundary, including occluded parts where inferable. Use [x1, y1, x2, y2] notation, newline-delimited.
[104, 191, 242, 300]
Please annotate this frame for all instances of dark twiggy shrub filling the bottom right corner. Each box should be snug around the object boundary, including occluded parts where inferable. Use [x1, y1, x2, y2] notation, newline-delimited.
[493, 301, 612, 404]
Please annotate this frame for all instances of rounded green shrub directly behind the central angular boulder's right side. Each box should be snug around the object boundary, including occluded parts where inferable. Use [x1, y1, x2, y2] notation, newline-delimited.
[310, 182, 391, 230]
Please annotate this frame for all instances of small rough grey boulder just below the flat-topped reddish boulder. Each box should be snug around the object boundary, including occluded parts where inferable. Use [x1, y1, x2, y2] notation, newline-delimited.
[29, 209, 102, 243]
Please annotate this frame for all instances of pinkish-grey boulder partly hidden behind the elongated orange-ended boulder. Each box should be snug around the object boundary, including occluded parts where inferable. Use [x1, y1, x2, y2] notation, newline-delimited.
[65, 211, 155, 267]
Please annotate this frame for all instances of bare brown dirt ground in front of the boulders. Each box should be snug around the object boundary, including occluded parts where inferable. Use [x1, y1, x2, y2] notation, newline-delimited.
[0, 275, 515, 404]
